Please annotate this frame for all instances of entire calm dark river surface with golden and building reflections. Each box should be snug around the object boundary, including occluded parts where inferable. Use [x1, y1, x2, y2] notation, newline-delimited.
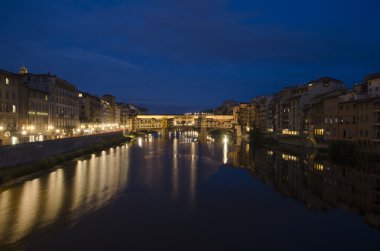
[0, 134, 380, 250]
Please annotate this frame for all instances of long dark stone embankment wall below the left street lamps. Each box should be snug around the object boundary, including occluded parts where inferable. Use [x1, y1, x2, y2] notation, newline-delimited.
[0, 132, 123, 168]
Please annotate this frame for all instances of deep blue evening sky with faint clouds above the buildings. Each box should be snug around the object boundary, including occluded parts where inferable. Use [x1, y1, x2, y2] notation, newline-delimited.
[0, 0, 380, 112]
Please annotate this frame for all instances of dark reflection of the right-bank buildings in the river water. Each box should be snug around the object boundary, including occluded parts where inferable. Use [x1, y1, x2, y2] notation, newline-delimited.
[229, 145, 380, 228]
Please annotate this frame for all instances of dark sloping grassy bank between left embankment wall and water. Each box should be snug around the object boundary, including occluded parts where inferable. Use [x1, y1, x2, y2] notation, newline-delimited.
[0, 133, 133, 189]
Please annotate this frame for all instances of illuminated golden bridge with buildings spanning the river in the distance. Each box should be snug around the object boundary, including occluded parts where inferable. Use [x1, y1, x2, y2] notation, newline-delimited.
[126, 114, 240, 137]
